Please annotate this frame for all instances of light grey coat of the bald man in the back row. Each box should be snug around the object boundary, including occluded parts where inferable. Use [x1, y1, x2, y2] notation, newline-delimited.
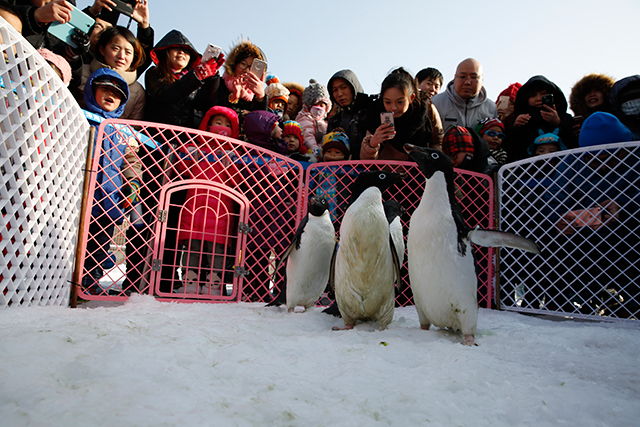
[431, 81, 498, 131]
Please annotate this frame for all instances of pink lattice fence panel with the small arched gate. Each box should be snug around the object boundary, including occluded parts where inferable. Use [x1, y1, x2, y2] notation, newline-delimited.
[77, 120, 303, 302]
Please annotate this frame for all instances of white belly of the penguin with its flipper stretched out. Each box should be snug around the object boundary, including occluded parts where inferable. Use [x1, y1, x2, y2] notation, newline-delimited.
[407, 184, 478, 335]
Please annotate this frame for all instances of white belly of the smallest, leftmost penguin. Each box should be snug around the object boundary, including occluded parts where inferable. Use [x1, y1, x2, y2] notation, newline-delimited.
[287, 216, 335, 310]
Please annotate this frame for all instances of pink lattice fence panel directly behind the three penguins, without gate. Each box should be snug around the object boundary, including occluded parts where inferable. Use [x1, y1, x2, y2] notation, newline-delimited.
[292, 161, 494, 307]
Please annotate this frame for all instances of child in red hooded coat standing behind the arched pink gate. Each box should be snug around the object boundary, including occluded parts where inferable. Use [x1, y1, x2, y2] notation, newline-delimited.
[177, 106, 240, 295]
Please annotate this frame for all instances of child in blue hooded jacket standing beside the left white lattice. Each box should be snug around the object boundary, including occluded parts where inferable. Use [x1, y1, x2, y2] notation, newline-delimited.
[82, 68, 142, 293]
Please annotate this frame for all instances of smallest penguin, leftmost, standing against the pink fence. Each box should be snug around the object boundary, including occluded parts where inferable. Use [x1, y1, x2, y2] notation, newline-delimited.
[267, 196, 336, 312]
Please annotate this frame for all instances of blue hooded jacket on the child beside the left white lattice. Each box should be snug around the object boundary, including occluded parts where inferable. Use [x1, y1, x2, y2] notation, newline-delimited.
[84, 68, 129, 224]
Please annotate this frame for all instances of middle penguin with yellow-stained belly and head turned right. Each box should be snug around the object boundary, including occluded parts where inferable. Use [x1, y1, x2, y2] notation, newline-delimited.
[330, 171, 404, 330]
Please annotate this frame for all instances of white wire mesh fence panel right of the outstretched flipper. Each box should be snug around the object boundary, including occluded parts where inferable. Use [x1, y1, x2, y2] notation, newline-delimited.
[498, 143, 640, 320]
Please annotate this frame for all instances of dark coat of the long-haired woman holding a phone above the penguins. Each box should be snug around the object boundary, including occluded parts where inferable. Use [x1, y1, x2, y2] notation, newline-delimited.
[363, 98, 432, 161]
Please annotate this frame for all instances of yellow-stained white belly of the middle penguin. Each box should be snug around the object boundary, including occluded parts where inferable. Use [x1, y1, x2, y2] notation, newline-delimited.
[335, 189, 395, 328]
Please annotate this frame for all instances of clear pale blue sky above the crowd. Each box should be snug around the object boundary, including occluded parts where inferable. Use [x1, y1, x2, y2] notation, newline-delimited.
[102, 0, 640, 110]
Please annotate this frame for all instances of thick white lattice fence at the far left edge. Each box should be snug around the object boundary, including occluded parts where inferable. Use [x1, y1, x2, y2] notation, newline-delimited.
[0, 18, 89, 308]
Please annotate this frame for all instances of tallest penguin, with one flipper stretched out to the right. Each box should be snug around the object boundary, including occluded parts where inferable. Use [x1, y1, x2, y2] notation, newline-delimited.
[404, 144, 540, 346]
